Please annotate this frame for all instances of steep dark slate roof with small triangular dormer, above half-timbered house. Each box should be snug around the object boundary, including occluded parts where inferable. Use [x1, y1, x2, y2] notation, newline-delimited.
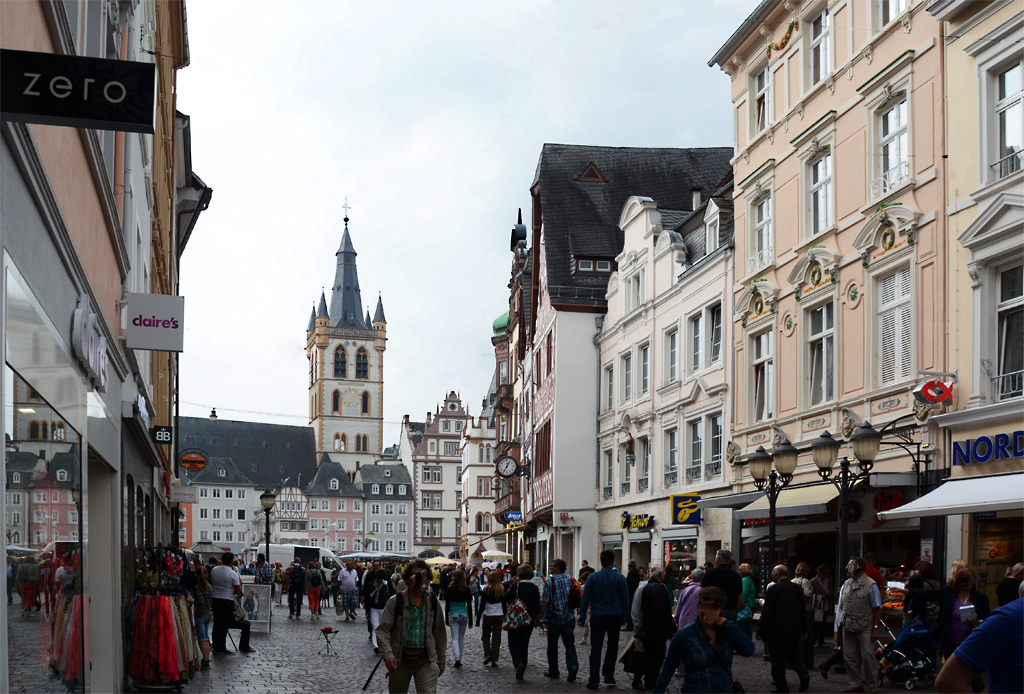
[531, 143, 733, 306]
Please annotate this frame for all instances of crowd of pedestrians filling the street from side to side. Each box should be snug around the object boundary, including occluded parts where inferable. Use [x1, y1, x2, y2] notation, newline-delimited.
[178, 550, 1024, 692]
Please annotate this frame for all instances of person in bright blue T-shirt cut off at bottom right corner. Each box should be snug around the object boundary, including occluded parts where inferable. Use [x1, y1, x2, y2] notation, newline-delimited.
[935, 584, 1024, 694]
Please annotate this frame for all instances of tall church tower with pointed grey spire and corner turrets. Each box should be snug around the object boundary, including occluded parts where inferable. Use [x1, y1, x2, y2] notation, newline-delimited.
[306, 214, 387, 470]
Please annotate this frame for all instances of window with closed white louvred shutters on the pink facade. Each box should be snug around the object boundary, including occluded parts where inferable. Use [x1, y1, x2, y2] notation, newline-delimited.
[879, 267, 913, 386]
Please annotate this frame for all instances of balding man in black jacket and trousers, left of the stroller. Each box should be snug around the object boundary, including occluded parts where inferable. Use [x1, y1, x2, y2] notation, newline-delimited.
[757, 564, 813, 692]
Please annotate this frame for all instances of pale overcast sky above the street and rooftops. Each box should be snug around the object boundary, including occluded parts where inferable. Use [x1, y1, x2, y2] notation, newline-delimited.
[177, 0, 757, 443]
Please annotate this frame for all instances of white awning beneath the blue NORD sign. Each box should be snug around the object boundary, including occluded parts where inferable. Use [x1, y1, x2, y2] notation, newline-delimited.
[879, 473, 1024, 520]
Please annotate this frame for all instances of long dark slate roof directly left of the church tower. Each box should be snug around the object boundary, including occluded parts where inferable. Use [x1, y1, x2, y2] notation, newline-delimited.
[179, 417, 316, 489]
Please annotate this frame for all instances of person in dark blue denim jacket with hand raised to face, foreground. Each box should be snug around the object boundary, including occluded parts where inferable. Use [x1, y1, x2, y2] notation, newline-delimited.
[654, 588, 757, 693]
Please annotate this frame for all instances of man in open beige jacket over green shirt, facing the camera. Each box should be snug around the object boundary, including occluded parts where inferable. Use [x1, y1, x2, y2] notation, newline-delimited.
[376, 559, 447, 694]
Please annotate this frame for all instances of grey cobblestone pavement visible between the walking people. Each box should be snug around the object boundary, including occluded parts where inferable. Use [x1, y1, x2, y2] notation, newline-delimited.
[183, 605, 934, 694]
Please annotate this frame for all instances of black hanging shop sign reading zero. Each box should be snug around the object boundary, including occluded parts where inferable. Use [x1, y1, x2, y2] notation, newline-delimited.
[0, 49, 157, 134]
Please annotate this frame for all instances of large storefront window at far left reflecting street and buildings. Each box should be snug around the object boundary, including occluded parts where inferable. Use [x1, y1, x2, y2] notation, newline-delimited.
[4, 367, 85, 692]
